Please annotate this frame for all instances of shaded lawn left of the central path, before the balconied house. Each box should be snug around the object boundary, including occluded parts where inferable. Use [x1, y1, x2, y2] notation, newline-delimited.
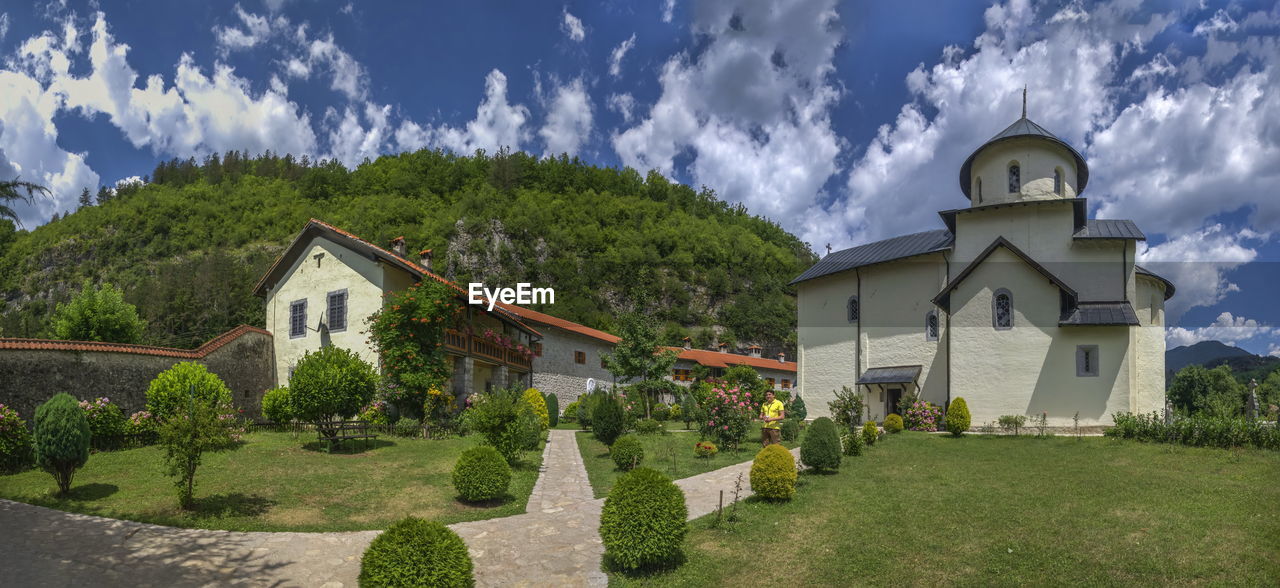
[0, 432, 541, 532]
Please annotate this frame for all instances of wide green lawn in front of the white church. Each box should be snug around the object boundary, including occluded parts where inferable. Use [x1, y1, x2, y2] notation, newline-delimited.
[609, 433, 1280, 585]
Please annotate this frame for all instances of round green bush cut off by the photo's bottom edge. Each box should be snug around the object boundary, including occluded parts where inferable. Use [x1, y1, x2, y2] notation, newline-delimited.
[360, 516, 475, 588]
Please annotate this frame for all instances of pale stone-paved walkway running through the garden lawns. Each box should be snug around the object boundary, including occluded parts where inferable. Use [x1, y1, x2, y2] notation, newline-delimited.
[0, 430, 795, 588]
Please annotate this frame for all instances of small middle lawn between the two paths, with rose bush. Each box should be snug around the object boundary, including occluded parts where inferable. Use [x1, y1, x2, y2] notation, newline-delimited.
[577, 423, 795, 498]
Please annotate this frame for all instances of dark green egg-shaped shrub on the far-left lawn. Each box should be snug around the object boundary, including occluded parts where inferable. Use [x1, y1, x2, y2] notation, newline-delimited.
[35, 392, 92, 494]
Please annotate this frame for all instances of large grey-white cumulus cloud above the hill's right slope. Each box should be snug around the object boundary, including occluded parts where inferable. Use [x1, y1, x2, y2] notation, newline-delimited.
[611, 0, 841, 238]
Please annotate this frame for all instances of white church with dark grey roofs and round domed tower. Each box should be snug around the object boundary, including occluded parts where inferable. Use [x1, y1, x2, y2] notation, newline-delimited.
[791, 106, 1174, 428]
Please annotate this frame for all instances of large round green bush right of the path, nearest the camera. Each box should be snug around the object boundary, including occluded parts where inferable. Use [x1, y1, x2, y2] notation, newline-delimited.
[600, 468, 689, 570]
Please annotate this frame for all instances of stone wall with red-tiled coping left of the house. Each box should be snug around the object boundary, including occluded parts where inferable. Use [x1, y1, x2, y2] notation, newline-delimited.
[0, 325, 275, 421]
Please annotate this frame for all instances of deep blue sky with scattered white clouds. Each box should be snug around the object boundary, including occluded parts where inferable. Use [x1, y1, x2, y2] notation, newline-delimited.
[0, 0, 1280, 355]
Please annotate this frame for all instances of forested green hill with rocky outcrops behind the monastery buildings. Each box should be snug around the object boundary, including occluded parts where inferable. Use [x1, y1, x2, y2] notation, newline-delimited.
[0, 150, 815, 347]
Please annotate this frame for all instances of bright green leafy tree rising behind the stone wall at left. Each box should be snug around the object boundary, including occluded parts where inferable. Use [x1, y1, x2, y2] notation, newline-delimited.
[54, 278, 146, 343]
